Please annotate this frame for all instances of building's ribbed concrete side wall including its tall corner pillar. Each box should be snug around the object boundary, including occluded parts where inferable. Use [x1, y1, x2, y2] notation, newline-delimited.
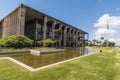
[2, 5, 25, 37]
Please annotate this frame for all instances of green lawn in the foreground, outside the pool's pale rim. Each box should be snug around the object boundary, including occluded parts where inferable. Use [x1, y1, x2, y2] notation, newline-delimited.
[0, 48, 120, 80]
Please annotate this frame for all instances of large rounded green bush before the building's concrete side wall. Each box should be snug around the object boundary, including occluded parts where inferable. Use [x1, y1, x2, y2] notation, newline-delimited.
[0, 35, 33, 48]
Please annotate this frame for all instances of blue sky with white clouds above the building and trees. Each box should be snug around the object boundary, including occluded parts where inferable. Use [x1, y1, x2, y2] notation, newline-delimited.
[0, 0, 120, 44]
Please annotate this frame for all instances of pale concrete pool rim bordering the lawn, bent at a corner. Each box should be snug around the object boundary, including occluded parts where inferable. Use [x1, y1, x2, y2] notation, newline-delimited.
[0, 51, 98, 72]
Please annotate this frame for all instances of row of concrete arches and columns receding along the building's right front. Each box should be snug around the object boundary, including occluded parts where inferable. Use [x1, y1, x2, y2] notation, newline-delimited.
[43, 17, 86, 47]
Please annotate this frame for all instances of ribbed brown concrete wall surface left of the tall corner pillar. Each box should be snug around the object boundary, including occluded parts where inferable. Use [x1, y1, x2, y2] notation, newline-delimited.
[2, 8, 20, 37]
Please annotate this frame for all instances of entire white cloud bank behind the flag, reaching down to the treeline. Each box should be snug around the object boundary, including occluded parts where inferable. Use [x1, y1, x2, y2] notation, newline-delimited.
[94, 13, 120, 45]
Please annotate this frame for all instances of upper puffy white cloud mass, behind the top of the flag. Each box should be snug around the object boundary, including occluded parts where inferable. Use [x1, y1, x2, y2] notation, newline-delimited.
[94, 14, 120, 29]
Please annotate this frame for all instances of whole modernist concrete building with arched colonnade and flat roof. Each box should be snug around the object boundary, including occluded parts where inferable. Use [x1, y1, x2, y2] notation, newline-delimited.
[0, 4, 88, 47]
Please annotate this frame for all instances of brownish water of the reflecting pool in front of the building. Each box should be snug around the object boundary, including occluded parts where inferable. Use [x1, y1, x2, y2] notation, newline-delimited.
[9, 48, 92, 68]
